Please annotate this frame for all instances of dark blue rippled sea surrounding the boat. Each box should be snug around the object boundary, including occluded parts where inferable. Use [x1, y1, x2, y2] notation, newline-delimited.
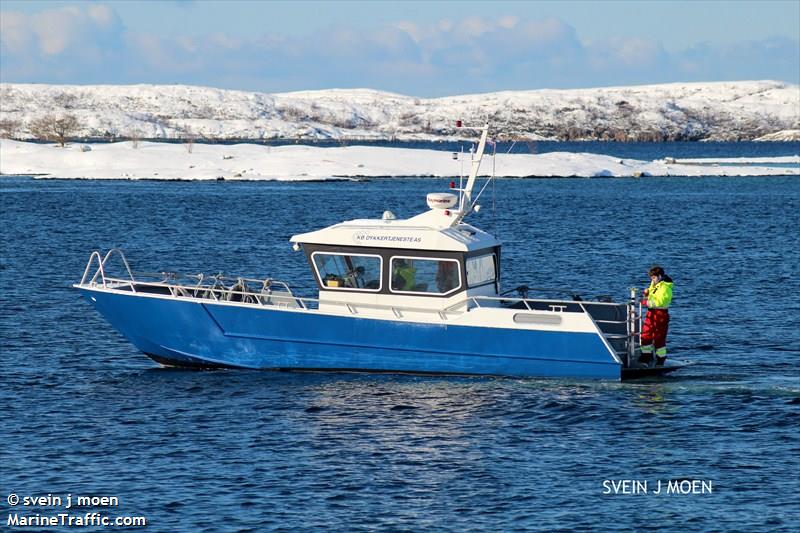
[0, 143, 800, 533]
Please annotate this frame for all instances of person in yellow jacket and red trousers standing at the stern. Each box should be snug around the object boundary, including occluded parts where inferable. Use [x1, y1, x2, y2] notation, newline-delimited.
[639, 265, 672, 366]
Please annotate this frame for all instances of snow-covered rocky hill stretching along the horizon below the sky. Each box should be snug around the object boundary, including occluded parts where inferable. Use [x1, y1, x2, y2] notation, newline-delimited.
[0, 81, 800, 141]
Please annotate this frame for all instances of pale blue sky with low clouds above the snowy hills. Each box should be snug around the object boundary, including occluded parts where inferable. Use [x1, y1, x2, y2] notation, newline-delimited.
[0, 0, 800, 97]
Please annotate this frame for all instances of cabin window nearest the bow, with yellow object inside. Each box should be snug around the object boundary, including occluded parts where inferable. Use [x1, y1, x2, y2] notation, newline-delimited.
[311, 252, 383, 292]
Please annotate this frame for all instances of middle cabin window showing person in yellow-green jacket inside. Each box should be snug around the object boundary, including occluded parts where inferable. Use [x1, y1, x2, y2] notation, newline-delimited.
[391, 257, 461, 294]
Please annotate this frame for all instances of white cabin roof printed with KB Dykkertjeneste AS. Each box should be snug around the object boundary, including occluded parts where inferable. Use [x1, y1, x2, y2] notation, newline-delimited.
[290, 209, 500, 252]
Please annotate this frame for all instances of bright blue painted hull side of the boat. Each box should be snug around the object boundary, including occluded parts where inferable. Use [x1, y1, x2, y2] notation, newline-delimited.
[81, 289, 621, 380]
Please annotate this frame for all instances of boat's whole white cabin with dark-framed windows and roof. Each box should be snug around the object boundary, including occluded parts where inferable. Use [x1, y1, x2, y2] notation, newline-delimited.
[291, 203, 500, 313]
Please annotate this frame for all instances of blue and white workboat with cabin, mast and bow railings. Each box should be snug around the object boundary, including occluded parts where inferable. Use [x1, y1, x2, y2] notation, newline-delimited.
[74, 122, 682, 380]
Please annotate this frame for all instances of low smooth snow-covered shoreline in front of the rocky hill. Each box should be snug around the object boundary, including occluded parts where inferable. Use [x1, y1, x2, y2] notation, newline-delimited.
[0, 139, 800, 181]
